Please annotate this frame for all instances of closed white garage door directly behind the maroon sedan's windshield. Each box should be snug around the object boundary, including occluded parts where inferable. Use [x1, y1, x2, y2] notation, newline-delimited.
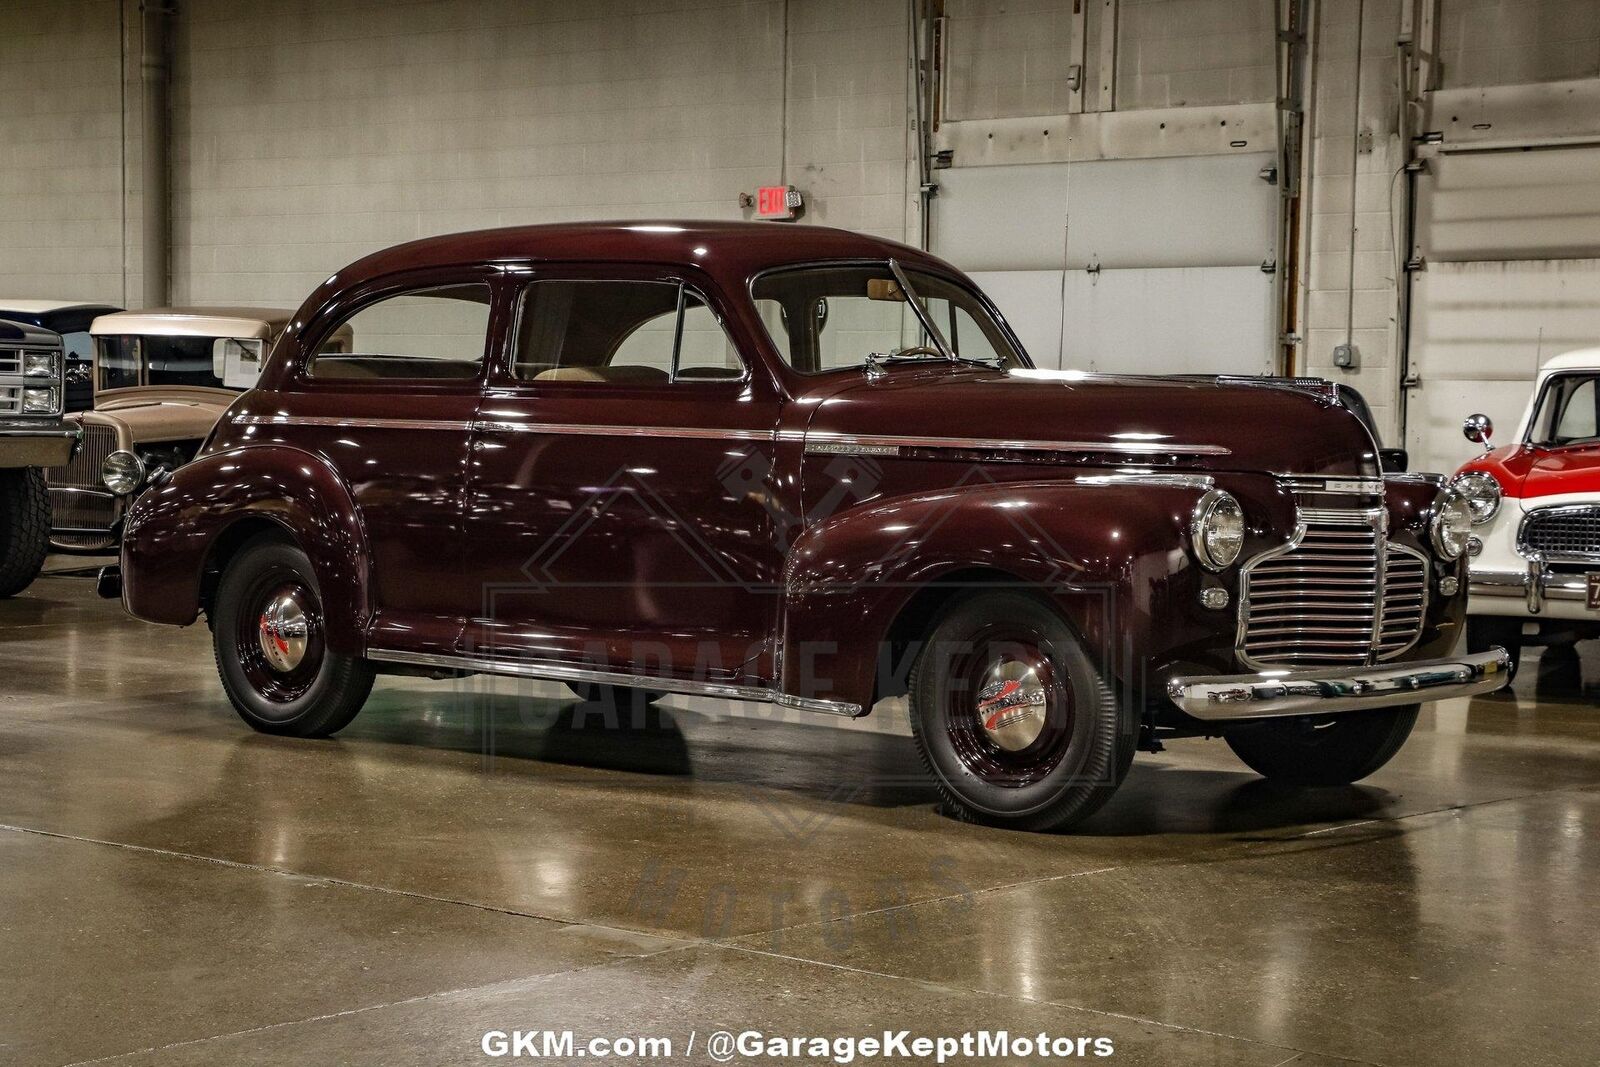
[933, 154, 1278, 374]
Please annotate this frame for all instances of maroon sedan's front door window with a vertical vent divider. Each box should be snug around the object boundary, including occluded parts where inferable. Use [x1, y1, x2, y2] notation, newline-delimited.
[514, 280, 744, 386]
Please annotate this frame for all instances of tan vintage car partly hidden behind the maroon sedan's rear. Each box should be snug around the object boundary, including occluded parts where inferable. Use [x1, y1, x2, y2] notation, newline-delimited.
[45, 307, 318, 552]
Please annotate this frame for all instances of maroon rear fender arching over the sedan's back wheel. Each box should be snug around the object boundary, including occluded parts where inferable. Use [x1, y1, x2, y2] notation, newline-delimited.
[122, 445, 371, 656]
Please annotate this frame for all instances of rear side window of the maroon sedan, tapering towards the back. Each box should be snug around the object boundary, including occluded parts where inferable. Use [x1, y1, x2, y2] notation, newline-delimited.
[306, 283, 490, 379]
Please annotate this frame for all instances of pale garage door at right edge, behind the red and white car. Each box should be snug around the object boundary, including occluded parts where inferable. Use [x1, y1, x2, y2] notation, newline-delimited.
[1406, 146, 1600, 472]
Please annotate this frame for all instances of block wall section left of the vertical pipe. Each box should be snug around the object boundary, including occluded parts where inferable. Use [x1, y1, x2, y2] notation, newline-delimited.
[0, 0, 123, 302]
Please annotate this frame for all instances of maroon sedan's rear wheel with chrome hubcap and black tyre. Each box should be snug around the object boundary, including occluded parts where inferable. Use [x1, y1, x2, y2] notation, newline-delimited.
[211, 537, 373, 737]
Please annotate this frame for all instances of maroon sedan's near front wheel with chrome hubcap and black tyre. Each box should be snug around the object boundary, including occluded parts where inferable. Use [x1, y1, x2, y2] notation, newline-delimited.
[910, 592, 1138, 830]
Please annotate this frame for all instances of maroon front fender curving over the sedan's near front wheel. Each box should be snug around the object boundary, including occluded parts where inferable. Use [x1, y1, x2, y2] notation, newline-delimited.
[782, 480, 1205, 707]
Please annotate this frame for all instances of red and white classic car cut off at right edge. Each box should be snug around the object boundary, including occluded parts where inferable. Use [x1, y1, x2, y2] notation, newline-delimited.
[1453, 349, 1600, 669]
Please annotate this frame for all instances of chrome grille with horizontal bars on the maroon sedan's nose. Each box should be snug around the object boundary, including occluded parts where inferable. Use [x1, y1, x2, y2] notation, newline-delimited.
[1238, 509, 1427, 667]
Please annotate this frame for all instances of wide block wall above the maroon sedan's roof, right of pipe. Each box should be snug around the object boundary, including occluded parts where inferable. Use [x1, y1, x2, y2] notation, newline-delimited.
[173, 0, 909, 306]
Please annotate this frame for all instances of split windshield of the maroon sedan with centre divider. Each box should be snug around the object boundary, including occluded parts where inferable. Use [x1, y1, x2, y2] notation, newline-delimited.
[750, 262, 1027, 374]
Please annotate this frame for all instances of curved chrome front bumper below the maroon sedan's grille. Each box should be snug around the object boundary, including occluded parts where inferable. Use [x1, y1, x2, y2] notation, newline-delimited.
[1166, 648, 1510, 721]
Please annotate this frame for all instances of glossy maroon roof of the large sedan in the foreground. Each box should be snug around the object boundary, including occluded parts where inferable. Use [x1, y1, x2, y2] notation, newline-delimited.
[328, 219, 938, 286]
